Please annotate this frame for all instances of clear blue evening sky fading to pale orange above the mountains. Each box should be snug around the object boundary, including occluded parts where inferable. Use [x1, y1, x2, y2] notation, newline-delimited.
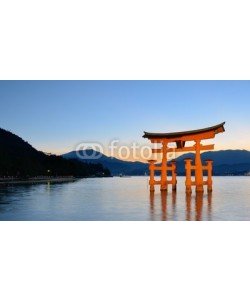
[0, 81, 250, 159]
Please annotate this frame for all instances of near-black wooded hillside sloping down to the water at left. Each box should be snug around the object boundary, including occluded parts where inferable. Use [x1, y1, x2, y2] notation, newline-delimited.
[0, 128, 110, 178]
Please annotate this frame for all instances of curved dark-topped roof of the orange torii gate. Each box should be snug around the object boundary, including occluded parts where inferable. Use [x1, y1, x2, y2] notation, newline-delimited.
[143, 122, 226, 141]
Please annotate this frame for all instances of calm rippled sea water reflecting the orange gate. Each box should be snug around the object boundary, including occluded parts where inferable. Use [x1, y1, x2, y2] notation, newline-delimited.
[0, 177, 250, 221]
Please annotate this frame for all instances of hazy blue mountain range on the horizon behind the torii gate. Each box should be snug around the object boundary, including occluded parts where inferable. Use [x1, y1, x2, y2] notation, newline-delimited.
[63, 150, 250, 176]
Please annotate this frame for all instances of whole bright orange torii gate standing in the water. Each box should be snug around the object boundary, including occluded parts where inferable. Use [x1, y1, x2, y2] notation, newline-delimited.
[143, 122, 225, 193]
